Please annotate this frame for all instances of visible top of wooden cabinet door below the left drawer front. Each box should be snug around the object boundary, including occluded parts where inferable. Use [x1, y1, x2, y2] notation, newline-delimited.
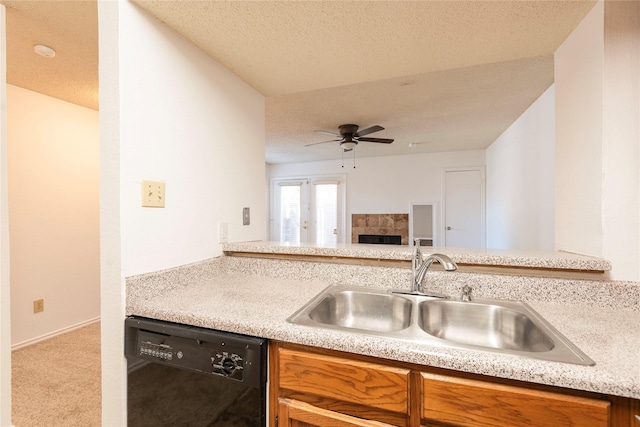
[278, 399, 392, 427]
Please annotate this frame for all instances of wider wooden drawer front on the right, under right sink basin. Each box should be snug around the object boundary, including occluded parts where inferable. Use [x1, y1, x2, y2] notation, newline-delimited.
[422, 373, 610, 427]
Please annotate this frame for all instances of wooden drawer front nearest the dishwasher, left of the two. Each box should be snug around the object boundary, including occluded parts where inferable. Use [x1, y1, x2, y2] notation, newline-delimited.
[279, 349, 409, 413]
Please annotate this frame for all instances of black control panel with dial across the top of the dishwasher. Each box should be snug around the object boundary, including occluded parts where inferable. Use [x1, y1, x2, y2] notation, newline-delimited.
[125, 318, 267, 385]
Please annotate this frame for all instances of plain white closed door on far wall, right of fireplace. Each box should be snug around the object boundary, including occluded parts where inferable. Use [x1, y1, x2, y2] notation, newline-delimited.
[443, 168, 485, 248]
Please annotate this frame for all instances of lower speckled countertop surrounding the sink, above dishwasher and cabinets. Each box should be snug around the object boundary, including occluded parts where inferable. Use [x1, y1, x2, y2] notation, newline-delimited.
[126, 269, 640, 399]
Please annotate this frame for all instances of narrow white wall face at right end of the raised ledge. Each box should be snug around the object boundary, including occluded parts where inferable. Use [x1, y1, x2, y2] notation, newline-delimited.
[555, 2, 604, 257]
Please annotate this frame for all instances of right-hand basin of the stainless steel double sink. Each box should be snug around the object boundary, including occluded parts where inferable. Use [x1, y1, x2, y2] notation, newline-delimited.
[418, 300, 554, 352]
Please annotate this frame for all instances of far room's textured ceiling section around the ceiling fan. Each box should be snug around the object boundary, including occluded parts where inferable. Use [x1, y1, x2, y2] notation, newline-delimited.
[266, 56, 553, 163]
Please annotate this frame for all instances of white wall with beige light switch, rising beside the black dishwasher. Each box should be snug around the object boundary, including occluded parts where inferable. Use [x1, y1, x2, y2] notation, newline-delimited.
[98, 2, 266, 425]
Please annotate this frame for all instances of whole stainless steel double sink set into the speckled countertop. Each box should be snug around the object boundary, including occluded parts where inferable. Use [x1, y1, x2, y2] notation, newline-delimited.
[287, 285, 595, 365]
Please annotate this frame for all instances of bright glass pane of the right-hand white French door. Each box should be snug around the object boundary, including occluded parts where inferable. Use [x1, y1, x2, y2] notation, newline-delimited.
[314, 184, 338, 245]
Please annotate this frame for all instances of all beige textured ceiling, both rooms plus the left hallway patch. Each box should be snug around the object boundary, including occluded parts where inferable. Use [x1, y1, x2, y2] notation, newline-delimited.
[0, 0, 595, 163]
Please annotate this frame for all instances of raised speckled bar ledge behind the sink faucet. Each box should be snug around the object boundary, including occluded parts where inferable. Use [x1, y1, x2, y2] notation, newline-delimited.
[223, 241, 611, 271]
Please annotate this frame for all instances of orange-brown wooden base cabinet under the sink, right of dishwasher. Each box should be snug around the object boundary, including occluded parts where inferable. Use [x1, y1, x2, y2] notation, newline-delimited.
[269, 342, 640, 427]
